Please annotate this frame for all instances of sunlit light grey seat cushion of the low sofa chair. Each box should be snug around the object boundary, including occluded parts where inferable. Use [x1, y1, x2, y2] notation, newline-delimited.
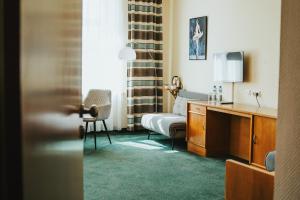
[141, 113, 186, 137]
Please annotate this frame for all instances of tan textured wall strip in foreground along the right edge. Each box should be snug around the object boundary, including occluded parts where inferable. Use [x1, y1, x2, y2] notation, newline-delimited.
[274, 0, 300, 200]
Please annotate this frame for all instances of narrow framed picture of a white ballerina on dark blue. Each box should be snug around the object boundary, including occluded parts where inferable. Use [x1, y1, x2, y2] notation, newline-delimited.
[189, 16, 207, 60]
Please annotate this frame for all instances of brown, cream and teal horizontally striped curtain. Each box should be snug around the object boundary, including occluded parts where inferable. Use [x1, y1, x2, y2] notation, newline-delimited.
[127, 0, 163, 131]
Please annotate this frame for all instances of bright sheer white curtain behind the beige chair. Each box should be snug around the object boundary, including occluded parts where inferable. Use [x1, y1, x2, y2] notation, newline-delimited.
[82, 0, 128, 130]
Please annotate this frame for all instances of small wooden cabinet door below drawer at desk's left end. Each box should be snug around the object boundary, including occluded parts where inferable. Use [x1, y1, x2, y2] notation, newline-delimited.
[188, 112, 205, 147]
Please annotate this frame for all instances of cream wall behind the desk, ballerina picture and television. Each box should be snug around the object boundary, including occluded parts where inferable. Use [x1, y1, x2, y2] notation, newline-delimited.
[169, 0, 281, 108]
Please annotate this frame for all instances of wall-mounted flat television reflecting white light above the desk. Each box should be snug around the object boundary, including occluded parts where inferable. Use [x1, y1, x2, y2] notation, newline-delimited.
[213, 51, 244, 83]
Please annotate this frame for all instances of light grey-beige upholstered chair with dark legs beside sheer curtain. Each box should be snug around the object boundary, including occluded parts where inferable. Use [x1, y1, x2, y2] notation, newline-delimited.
[83, 89, 111, 149]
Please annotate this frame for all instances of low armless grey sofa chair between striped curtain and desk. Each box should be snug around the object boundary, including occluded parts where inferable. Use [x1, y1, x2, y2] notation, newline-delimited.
[141, 90, 208, 150]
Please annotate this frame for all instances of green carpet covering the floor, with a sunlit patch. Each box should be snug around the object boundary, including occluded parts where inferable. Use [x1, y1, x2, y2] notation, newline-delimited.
[84, 134, 225, 200]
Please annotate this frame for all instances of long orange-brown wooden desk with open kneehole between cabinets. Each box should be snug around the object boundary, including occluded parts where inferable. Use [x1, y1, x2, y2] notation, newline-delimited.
[186, 101, 277, 168]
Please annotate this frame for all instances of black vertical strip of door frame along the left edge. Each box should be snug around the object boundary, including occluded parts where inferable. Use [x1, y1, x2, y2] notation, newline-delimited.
[0, 0, 22, 199]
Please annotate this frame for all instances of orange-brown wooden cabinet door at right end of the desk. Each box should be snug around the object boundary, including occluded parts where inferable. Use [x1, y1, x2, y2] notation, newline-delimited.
[252, 116, 276, 167]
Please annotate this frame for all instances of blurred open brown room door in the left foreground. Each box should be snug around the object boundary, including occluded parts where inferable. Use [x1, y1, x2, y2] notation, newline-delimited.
[20, 0, 83, 200]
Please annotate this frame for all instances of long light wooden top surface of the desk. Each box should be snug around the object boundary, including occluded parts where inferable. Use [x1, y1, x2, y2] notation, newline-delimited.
[188, 101, 277, 119]
